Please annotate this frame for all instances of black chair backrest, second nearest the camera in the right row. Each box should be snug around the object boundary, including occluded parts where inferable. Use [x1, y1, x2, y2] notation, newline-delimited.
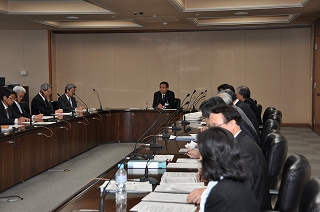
[274, 154, 311, 212]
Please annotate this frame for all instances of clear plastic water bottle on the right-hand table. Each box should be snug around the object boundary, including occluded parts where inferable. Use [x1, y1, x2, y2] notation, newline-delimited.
[115, 164, 127, 212]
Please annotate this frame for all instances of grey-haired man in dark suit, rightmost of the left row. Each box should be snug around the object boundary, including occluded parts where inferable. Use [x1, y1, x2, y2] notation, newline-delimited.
[58, 84, 84, 112]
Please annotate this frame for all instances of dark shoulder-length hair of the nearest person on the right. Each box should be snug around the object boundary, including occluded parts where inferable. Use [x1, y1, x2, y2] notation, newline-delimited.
[198, 127, 248, 182]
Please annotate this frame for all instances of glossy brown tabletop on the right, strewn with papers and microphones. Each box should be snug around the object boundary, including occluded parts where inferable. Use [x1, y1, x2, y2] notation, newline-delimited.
[52, 123, 200, 212]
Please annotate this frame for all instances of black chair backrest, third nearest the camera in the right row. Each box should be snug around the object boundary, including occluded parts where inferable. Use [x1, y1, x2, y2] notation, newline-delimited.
[262, 131, 288, 189]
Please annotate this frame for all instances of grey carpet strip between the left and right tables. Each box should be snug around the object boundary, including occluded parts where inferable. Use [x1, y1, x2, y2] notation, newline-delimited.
[0, 143, 134, 212]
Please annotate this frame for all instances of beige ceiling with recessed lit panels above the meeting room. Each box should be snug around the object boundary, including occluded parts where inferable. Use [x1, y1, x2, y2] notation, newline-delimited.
[0, 0, 320, 32]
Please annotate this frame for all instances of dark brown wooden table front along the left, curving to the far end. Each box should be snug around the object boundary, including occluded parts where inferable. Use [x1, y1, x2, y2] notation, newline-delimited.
[0, 109, 178, 192]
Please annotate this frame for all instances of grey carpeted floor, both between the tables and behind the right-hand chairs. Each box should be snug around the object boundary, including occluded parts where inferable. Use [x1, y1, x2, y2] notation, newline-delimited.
[0, 127, 320, 212]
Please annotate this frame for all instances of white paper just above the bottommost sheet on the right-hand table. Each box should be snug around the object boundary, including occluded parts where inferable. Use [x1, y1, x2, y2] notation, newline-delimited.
[142, 192, 188, 204]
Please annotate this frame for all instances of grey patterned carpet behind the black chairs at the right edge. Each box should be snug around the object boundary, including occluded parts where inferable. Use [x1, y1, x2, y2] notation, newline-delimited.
[280, 127, 320, 178]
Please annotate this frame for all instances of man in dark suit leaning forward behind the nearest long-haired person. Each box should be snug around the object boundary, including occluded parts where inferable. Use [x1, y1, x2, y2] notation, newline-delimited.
[188, 106, 272, 210]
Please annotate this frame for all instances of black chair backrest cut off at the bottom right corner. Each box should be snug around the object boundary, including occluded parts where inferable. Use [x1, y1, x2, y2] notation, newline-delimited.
[299, 177, 320, 212]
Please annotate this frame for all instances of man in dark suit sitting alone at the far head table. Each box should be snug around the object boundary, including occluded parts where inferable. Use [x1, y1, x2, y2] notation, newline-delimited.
[152, 82, 175, 109]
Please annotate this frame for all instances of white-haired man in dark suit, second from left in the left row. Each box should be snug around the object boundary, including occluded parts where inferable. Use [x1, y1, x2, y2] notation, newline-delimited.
[11, 85, 43, 119]
